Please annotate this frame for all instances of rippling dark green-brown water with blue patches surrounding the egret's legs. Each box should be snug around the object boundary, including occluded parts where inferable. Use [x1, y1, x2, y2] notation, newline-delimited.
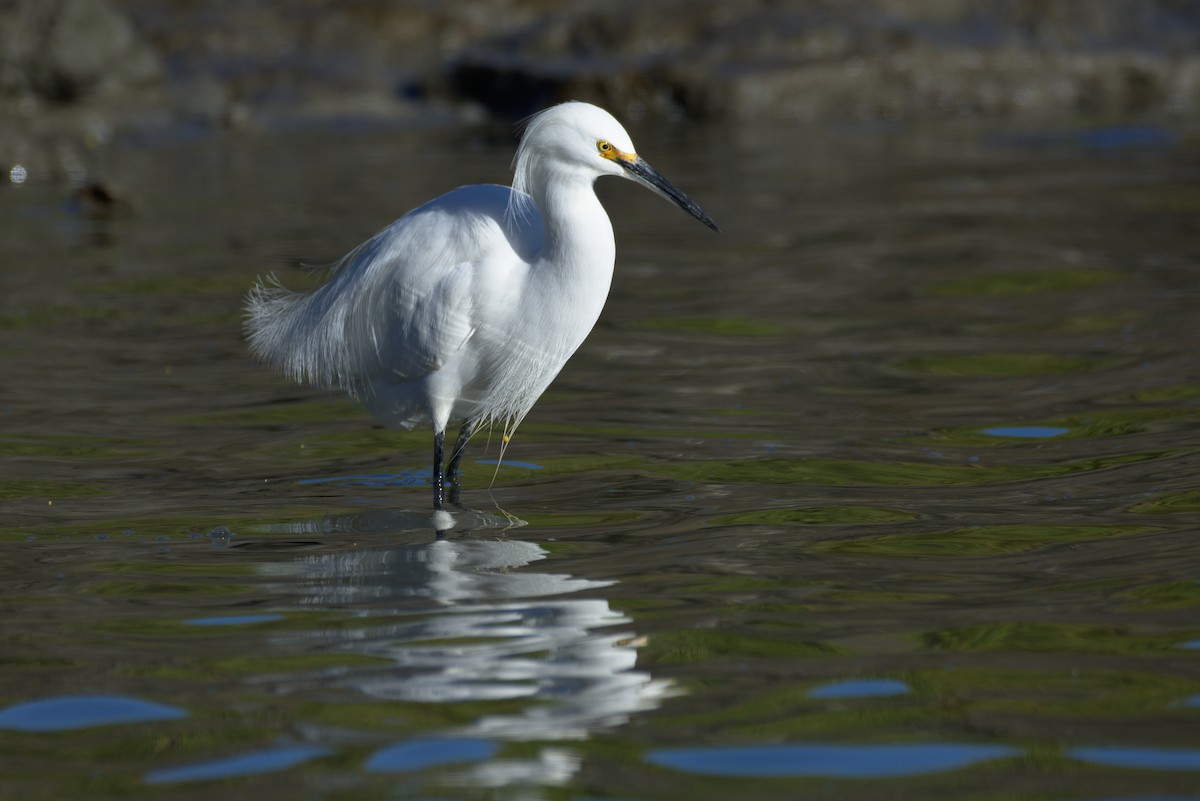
[0, 113, 1200, 801]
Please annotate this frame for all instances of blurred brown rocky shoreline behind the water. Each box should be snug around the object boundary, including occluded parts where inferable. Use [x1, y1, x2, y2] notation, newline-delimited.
[0, 0, 1200, 179]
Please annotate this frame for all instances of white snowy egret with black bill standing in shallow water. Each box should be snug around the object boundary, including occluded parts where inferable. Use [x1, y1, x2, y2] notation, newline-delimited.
[246, 102, 718, 508]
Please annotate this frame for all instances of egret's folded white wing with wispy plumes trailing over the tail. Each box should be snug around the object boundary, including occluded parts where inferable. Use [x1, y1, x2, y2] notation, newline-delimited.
[247, 186, 532, 392]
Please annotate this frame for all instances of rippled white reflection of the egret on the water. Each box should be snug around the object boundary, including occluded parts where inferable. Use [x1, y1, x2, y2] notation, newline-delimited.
[256, 513, 670, 767]
